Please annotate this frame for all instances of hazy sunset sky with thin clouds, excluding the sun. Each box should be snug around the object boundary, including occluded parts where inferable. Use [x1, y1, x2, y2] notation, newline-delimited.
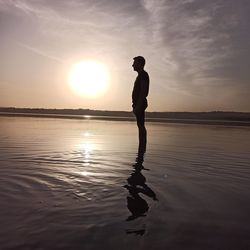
[0, 0, 250, 112]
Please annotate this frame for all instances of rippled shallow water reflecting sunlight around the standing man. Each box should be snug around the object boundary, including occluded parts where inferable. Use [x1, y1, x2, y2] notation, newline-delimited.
[0, 117, 250, 250]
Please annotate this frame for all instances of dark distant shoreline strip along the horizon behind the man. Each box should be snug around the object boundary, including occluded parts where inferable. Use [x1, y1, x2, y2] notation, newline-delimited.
[0, 108, 250, 126]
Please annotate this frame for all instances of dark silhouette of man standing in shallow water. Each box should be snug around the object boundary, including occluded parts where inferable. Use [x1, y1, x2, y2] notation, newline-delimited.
[132, 56, 149, 151]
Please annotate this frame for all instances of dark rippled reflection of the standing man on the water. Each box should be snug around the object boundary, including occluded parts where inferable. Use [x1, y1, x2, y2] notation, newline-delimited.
[124, 134, 158, 235]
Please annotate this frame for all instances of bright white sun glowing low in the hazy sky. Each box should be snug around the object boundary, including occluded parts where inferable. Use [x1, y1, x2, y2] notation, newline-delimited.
[68, 61, 109, 97]
